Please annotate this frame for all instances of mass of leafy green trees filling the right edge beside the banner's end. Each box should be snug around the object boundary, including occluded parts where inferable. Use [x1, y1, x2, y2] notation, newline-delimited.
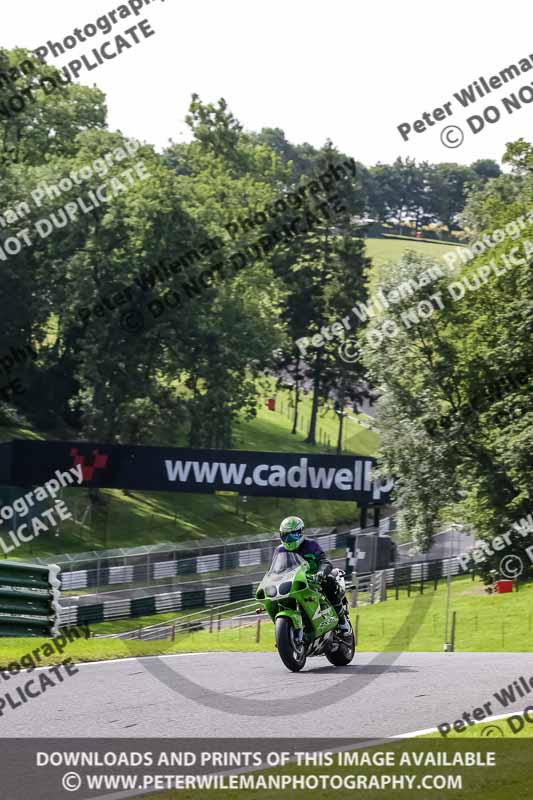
[365, 140, 533, 572]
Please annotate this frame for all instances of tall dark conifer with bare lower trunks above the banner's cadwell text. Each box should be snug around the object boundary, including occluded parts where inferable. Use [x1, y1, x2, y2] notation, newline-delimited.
[262, 143, 368, 443]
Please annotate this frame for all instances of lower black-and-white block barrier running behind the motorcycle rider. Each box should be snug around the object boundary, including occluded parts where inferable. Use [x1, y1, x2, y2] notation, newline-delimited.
[61, 556, 464, 625]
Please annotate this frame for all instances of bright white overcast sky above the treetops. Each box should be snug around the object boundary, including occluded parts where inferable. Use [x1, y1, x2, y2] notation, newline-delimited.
[2, 0, 533, 165]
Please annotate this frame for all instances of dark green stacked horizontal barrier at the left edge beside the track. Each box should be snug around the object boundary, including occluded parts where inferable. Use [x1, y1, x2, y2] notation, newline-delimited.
[0, 561, 63, 637]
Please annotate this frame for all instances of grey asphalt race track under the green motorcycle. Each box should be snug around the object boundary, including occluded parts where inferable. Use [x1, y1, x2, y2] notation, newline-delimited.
[0, 652, 533, 738]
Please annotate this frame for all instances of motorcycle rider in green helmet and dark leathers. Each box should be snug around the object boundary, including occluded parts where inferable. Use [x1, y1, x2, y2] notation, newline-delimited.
[276, 517, 352, 635]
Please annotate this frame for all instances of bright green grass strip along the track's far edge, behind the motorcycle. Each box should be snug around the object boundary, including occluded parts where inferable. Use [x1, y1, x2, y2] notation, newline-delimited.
[0, 577, 533, 666]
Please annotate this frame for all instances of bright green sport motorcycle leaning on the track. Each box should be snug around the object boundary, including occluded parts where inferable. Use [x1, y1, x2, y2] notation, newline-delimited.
[255, 550, 355, 672]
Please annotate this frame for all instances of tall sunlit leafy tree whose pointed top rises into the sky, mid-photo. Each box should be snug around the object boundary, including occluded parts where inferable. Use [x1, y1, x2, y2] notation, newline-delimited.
[161, 96, 287, 447]
